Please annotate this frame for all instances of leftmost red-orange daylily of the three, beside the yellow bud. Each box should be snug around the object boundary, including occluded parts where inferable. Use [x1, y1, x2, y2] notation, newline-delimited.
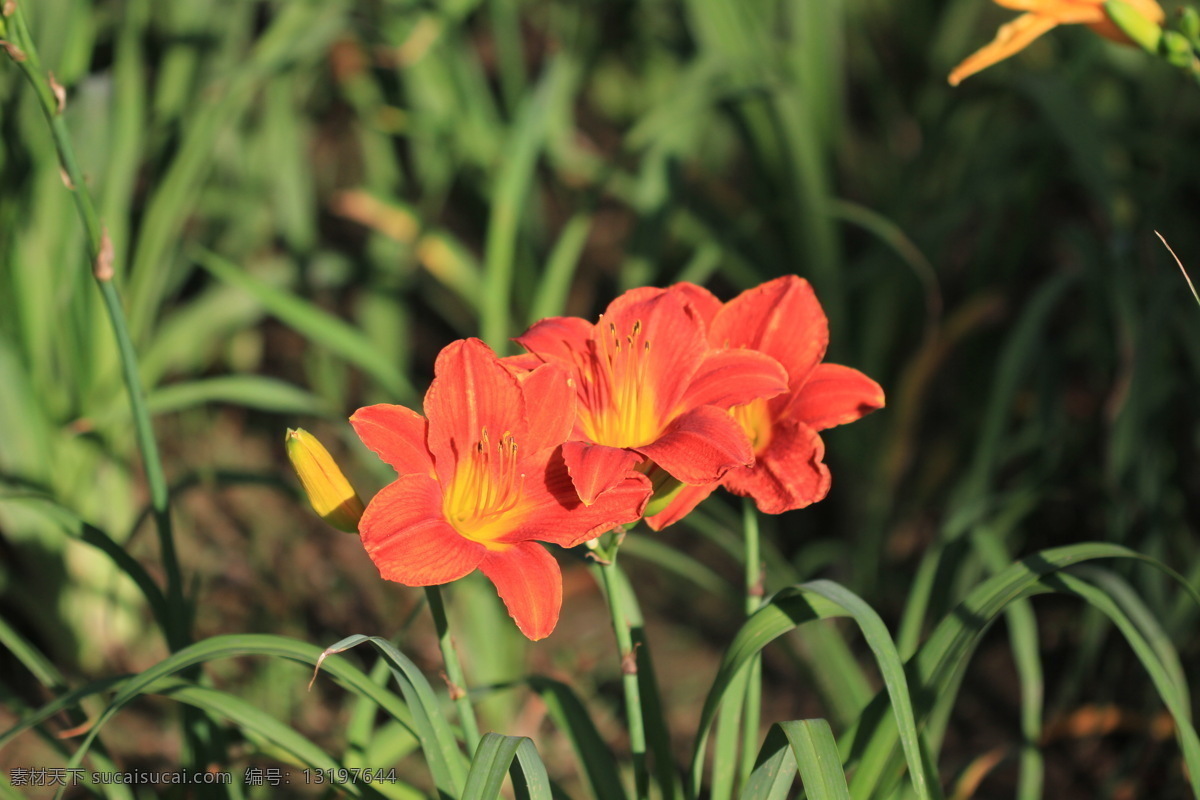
[350, 339, 650, 640]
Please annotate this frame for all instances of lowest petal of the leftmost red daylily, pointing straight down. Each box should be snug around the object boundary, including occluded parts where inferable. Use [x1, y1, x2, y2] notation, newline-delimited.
[479, 542, 563, 642]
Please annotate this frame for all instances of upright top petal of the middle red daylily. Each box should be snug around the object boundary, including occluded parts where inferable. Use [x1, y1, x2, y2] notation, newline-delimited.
[595, 289, 708, 420]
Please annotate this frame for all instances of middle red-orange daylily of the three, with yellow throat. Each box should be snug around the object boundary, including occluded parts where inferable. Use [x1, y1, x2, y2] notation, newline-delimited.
[517, 284, 787, 505]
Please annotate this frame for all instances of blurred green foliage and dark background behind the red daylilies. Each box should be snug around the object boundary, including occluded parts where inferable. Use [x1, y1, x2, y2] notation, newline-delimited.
[0, 0, 1200, 798]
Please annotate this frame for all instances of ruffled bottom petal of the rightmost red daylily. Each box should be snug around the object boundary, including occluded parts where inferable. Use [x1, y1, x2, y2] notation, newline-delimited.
[721, 420, 829, 513]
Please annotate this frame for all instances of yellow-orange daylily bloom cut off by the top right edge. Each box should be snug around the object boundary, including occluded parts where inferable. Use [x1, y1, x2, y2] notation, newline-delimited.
[949, 0, 1165, 86]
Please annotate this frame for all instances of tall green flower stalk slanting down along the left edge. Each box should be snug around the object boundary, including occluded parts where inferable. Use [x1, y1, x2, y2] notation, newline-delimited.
[0, 5, 191, 650]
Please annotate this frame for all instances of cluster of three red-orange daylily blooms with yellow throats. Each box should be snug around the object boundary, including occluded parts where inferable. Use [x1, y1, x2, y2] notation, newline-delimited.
[290, 276, 883, 639]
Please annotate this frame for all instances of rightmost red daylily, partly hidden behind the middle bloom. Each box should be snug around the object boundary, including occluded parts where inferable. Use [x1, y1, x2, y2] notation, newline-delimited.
[647, 275, 883, 530]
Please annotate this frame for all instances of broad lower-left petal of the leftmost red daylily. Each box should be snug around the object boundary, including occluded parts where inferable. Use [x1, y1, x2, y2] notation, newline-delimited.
[359, 475, 487, 587]
